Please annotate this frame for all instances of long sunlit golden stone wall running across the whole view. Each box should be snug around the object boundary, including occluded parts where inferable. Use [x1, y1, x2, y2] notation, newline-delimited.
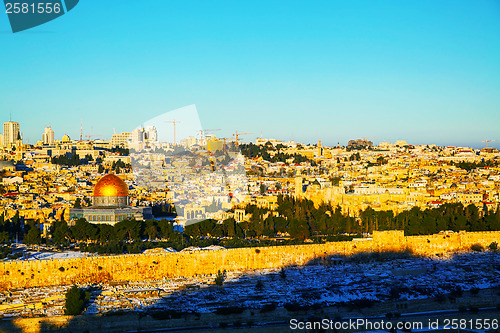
[0, 231, 500, 290]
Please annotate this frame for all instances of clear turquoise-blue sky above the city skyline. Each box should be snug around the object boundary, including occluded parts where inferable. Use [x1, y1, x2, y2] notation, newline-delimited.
[0, 0, 500, 147]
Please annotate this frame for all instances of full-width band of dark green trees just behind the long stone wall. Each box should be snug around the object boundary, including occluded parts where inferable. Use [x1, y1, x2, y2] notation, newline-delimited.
[0, 196, 500, 253]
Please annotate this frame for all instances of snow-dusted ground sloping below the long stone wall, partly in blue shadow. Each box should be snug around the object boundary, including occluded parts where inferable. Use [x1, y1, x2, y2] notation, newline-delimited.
[0, 252, 500, 316]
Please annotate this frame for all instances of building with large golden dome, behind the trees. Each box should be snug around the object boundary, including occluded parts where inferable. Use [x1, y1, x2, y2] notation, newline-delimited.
[70, 174, 153, 225]
